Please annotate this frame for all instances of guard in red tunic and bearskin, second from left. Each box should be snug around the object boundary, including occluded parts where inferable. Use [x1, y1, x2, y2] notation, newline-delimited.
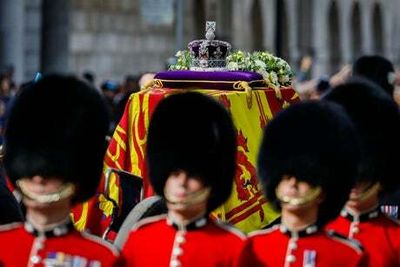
[122, 92, 245, 266]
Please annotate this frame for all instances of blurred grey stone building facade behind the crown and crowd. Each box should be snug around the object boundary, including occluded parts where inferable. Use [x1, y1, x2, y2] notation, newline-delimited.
[0, 0, 400, 82]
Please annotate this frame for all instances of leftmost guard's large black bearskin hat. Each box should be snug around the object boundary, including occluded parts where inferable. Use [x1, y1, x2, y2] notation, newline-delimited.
[4, 75, 108, 202]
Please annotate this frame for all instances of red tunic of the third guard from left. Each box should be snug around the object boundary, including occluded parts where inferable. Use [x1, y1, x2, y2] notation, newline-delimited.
[240, 225, 364, 267]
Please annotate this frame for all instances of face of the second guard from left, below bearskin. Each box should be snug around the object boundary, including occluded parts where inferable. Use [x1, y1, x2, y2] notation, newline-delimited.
[164, 170, 209, 214]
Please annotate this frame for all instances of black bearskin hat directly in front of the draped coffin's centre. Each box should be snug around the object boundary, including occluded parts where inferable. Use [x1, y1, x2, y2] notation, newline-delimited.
[147, 92, 236, 214]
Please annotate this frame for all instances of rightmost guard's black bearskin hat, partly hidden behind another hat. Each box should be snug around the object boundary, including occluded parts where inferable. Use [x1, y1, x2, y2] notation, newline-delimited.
[324, 78, 400, 194]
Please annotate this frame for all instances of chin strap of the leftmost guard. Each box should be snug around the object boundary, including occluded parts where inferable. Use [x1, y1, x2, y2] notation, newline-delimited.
[17, 180, 75, 204]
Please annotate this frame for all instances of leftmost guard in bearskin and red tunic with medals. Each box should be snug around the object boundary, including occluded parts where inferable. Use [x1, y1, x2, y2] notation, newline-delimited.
[0, 75, 122, 266]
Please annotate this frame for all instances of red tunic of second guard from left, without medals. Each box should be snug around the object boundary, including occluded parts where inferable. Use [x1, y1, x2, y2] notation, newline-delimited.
[122, 215, 245, 267]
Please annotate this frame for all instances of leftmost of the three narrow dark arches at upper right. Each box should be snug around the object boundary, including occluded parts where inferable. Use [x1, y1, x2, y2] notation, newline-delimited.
[328, 1, 341, 73]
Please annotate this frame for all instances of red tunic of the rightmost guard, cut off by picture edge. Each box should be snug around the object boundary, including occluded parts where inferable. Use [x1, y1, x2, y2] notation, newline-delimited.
[327, 209, 400, 267]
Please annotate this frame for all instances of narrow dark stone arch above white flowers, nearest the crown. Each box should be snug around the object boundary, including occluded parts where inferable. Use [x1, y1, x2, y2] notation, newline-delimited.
[250, 0, 264, 50]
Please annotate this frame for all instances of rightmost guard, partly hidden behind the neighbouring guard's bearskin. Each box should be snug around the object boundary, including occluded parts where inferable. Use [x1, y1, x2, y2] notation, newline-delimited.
[324, 79, 400, 266]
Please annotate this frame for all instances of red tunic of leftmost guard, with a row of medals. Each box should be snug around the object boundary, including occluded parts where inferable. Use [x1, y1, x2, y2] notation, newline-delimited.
[0, 223, 122, 267]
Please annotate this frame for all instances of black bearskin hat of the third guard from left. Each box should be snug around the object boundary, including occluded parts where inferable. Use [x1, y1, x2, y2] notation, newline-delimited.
[257, 102, 359, 226]
